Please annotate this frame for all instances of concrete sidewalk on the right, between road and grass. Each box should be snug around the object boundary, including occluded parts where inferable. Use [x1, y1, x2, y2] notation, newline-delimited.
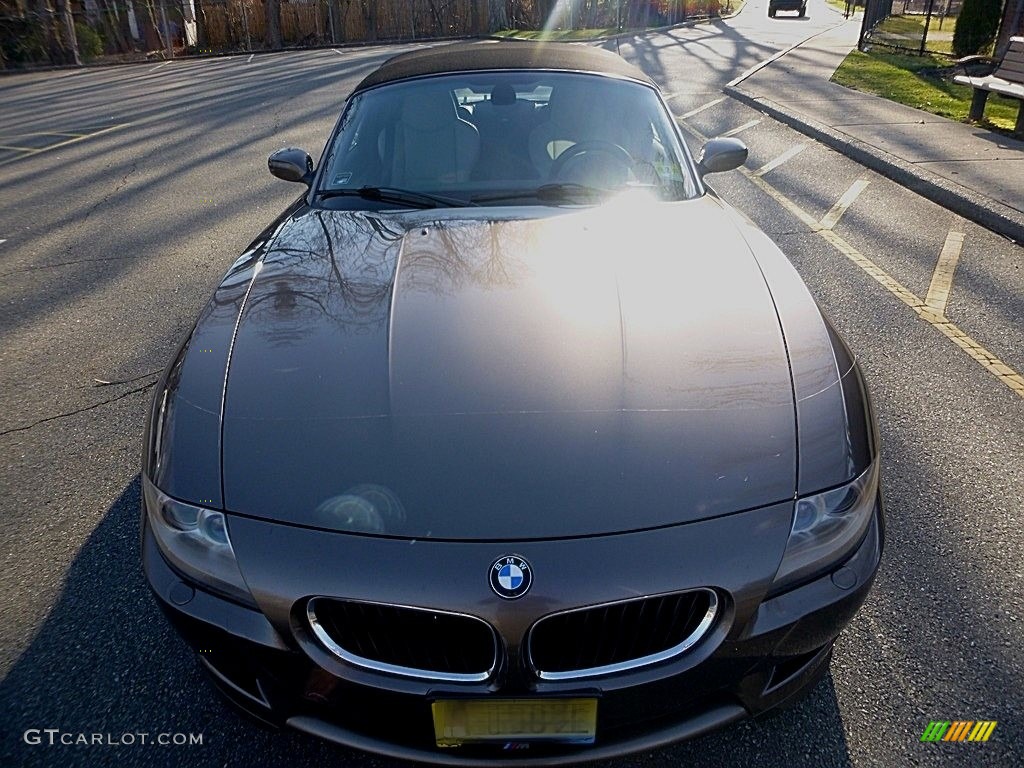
[726, 15, 1024, 243]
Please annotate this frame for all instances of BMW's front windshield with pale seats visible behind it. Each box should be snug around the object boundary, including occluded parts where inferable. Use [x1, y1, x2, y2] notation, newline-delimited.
[316, 71, 697, 207]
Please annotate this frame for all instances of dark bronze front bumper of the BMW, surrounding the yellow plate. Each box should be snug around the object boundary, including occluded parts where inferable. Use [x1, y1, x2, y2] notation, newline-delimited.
[142, 498, 884, 766]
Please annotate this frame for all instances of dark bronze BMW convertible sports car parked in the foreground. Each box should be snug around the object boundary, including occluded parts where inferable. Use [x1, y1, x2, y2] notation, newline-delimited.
[142, 43, 884, 765]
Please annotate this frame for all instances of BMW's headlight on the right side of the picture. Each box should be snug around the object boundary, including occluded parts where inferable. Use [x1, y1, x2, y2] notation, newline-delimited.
[771, 459, 879, 593]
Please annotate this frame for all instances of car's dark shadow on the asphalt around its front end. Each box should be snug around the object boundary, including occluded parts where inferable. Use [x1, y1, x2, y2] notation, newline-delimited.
[0, 475, 850, 768]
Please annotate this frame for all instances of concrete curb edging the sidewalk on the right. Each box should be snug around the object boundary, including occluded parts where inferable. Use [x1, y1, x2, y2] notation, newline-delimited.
[722, 85, 1024, 244]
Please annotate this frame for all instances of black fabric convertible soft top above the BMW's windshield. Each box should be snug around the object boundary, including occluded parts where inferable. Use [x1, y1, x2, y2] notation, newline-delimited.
[355, 40, 654, 92]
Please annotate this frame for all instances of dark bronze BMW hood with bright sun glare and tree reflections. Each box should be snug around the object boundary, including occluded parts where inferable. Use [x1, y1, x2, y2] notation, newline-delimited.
[222, 197, 797, 541]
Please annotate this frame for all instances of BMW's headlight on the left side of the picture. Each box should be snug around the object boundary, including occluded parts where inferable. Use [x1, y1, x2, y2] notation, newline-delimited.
[142, 475, 256, 607]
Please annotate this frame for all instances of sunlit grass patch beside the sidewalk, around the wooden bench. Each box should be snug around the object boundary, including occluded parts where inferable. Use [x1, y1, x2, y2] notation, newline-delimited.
[833, 50, 1019, 132]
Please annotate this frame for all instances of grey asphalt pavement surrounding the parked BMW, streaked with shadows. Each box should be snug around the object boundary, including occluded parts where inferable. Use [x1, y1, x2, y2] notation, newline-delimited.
[0, 0, 1024, 767]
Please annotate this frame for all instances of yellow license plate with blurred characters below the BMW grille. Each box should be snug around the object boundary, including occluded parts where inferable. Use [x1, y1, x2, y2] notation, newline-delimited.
[431, 698, 597, 746]
